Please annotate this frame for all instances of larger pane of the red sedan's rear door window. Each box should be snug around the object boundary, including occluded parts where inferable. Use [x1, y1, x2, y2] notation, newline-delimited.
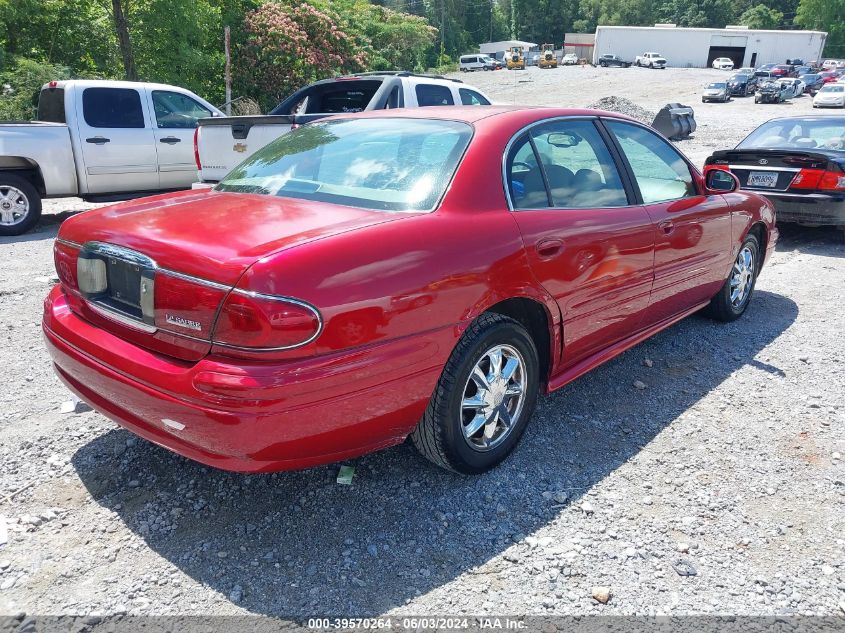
[531, 120, 628, 209]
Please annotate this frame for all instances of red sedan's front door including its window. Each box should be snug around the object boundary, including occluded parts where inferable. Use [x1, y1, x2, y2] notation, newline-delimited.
[605, 120, 732, 323]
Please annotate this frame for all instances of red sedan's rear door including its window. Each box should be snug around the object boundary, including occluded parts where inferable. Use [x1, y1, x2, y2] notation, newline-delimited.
[506, 119, 654, 365]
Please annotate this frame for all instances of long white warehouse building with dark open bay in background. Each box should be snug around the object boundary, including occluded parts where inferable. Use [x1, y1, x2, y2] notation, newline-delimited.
[593, 24, 827, 68]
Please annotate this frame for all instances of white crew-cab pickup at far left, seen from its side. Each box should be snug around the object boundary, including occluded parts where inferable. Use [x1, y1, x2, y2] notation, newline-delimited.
[0, 80, 223, 235]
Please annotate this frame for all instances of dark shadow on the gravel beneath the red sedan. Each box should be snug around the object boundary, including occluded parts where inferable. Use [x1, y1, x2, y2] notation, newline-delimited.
[73, 292, 798, 617]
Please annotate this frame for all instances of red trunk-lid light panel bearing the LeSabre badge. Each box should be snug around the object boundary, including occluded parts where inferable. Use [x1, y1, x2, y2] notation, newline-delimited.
[153, 273, 228, 340]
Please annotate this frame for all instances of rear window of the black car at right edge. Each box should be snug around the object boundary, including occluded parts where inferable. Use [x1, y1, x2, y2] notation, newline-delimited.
[736, 117, 845, 150]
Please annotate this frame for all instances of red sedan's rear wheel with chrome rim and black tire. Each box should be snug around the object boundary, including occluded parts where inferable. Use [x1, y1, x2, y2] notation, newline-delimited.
[411, 313, 540, 474]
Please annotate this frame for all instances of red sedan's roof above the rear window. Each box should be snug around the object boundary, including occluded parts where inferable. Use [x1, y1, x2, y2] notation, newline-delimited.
[332, 105, 635, 124]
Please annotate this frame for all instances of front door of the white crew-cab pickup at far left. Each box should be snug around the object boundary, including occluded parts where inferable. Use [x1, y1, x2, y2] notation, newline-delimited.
[146, 90, 212, 189]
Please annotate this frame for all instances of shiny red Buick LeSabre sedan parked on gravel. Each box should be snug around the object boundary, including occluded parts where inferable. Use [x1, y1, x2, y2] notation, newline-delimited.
[43, 106, 777, 473]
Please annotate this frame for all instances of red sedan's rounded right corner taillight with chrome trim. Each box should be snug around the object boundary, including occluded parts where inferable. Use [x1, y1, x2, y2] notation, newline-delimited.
[213, 290, 322, 352]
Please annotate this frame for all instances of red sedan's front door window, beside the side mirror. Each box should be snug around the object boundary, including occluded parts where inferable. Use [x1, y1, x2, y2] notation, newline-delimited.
[607, 121, 697, 204]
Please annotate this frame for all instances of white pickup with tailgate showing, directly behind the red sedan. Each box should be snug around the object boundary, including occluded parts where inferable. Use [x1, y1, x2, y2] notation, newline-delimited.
[194, 72, 490, 188]
